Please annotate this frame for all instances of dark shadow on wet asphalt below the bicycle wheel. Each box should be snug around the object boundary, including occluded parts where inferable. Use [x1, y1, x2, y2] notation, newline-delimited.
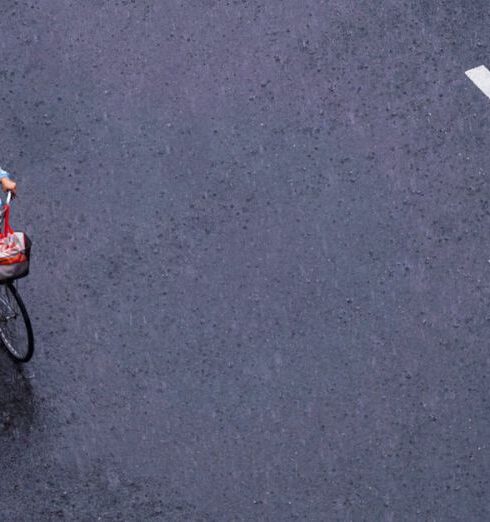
[0, 353, 35, 438]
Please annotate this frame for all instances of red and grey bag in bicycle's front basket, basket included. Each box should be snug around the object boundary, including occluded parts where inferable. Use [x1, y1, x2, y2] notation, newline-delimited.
[0, 205, 31, 283]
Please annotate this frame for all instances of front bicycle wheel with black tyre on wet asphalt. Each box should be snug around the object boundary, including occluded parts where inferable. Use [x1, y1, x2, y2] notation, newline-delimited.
[0, 283, 34, 362]
